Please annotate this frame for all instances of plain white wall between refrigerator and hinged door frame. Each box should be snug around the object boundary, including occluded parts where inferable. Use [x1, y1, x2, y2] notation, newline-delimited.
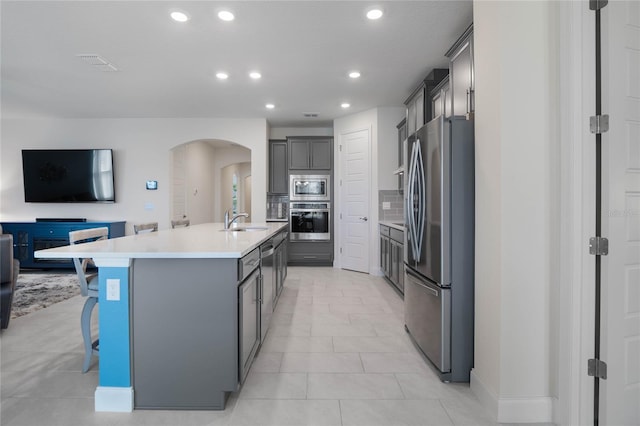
[472, 1, 559, 422]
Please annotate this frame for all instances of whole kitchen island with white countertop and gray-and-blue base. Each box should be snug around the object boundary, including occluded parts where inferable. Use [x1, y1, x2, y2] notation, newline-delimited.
[35, 223, 287, 411]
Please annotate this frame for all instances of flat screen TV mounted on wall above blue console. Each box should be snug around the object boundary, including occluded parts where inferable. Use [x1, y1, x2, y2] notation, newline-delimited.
[22, 149, 115, 203]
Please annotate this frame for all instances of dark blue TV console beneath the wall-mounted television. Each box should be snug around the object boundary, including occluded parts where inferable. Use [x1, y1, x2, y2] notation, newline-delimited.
[2, 219, 126, 269]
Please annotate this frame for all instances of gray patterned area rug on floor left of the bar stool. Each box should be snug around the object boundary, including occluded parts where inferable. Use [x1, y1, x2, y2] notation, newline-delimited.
[11, 272, 80, 318]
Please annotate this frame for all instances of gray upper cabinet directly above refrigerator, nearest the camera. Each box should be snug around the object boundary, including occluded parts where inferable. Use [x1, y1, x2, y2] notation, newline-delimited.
[446, 24, 475, 119]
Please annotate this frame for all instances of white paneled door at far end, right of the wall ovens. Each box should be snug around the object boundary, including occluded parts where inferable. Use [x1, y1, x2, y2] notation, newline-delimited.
[338, 130, 371, 272]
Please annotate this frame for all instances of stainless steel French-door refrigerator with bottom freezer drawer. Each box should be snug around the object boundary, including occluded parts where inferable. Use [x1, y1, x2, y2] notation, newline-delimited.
[404, 116, 475, 382]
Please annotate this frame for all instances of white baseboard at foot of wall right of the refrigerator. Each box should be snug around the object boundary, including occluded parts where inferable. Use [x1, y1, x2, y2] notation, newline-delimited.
[470, 370, 554, 423]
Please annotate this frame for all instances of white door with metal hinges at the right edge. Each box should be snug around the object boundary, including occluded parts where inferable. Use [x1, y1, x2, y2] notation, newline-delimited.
[600, 0, 640, 425]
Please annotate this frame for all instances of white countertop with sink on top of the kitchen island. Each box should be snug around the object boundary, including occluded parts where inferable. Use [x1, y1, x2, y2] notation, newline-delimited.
[34, 222, 287, 259]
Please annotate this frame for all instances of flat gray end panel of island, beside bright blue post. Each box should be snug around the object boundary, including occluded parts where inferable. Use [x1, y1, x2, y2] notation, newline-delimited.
[132, 259, 238, 409]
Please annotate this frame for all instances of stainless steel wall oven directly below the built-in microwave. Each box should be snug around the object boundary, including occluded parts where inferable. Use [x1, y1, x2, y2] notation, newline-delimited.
[289, 202, 331, 241]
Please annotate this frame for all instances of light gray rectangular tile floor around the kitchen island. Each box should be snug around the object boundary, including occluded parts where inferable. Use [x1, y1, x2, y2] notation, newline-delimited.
[0, 267, 494, 426]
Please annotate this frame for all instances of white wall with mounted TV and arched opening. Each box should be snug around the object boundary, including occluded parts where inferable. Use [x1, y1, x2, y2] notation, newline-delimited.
[0, 119, 267, 233]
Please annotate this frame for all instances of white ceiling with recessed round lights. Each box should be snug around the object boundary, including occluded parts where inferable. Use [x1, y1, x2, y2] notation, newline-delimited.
[0, 0, 473, 127]
